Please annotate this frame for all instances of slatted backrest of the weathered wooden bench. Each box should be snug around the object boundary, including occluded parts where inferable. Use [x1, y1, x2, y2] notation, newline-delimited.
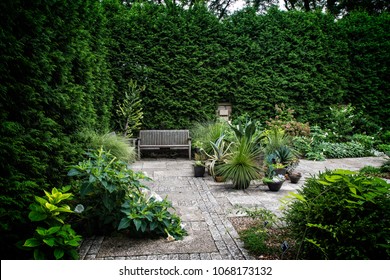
[139, 130, 190, 146]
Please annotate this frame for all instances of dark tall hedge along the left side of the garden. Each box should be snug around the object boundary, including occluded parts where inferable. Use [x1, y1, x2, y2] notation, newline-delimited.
[0, 0, 113, 258]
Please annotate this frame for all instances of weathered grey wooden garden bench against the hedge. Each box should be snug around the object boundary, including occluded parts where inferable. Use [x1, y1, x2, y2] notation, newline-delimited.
[137, 130, 191, 159]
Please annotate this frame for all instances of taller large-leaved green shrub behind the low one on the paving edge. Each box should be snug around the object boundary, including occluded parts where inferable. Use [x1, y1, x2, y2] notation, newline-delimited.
[68, 148, 147, 234]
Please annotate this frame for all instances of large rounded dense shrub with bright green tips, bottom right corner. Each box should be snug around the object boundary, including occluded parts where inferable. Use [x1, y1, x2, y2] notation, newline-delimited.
[285, 170, 390, 259]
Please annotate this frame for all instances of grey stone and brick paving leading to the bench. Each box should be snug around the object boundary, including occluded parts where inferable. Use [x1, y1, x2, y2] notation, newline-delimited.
[80, 157, 384, 260]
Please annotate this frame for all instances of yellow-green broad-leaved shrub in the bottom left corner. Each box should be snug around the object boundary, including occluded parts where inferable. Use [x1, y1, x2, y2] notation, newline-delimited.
[23, 187, 81, 260]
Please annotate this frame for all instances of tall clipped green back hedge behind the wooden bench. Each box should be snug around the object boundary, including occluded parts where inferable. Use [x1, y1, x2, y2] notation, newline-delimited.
[105, 1, 389, 132]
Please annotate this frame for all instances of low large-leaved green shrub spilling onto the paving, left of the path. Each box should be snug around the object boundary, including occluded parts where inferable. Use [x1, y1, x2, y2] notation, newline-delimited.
[118, 191, 186, 240]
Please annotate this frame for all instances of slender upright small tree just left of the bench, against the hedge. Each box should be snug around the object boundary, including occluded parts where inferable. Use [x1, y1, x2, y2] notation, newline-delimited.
[116, 80, 145, 137]
